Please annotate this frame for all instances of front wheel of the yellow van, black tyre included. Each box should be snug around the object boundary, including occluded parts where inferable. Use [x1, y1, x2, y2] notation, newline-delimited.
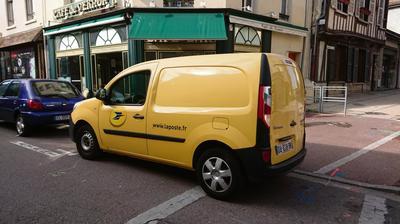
[75, 125, 101, 160]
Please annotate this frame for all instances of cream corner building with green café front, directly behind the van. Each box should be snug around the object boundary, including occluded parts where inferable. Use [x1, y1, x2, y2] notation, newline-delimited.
[44, 0, 311, 90]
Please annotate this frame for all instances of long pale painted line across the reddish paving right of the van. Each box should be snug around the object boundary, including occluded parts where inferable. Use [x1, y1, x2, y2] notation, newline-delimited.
[314, 131, 400, 174]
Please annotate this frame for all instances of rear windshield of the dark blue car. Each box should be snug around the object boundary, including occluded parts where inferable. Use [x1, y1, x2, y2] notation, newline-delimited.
[32, 81, 79, 99]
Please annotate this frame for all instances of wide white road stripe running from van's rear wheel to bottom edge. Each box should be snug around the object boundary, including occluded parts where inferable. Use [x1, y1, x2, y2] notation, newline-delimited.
[127, 186, 206, 224]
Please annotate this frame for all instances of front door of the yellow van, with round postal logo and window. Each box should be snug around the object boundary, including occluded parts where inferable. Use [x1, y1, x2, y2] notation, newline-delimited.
[99, 63, 157, 155]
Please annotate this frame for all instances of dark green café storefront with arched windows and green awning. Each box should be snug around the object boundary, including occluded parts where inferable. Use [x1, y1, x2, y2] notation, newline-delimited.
[44, 6, 307, 90]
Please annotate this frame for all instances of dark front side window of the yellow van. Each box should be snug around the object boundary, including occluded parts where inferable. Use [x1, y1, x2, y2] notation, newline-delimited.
[110, 70, 151, 105]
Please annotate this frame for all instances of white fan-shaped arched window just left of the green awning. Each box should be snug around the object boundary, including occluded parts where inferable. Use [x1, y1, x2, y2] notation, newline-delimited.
[90, 25, 127, 46]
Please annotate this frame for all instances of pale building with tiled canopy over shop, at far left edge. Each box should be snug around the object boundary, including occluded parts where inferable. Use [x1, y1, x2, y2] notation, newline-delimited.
[0, 0, 46, 80]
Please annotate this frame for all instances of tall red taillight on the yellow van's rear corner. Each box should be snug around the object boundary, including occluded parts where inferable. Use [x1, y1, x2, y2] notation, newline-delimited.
[258, 86, 272, 128]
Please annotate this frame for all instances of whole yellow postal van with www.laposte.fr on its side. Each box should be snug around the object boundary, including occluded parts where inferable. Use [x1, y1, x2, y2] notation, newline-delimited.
[70, 53, 306, 198]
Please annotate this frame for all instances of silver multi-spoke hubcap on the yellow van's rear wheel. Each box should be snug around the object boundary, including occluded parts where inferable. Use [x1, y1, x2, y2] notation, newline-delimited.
[202, 157, 232, 192]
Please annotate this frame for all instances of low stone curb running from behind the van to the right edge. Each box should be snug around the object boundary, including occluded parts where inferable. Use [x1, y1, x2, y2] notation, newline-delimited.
[292, 170, 400, 195]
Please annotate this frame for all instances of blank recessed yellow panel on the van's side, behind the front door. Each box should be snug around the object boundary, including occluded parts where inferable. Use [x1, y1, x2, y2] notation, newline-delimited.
[156, 67, 250, 107]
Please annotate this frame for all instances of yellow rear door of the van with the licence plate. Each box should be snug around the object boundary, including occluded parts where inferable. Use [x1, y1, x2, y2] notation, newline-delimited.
[269, 58, 304, 165]
